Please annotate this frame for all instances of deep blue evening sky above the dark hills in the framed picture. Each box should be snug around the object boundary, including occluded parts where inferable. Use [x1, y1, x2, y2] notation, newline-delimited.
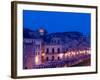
[23, 10, 91, 35]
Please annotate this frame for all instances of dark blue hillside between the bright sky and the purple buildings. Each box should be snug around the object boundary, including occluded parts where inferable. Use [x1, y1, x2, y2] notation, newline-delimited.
[23, 29, 90, 44]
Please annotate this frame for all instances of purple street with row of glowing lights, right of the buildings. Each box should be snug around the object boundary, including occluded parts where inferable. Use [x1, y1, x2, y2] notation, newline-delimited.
[30, 50, 91, 68]
